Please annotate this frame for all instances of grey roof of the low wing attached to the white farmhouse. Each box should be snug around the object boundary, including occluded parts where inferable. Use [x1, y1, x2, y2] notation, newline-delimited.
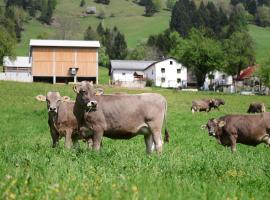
[111, 60, 155, 71]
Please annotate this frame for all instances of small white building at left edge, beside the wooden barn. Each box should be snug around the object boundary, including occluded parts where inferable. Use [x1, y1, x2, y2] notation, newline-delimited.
[0, 56, 33, 82]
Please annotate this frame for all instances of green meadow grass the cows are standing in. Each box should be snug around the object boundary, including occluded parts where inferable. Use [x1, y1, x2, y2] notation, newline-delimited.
[0, 81, 270, 199]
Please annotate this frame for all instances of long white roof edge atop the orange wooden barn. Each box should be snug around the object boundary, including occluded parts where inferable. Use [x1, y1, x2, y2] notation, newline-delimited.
[30, 40, 100, 48]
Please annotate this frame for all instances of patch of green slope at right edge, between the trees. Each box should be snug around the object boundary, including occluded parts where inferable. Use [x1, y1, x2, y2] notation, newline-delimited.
[249, 25, 270, 64]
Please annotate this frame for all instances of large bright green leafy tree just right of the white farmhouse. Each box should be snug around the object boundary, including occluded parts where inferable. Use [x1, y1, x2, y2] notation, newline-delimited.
[170, 29, 224, 88]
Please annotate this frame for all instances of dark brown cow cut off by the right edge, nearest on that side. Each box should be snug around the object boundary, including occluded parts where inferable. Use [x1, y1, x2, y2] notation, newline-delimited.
[202, 113, 270, 152]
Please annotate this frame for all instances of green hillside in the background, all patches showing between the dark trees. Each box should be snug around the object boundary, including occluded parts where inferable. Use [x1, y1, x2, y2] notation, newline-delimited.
[0, 0, 270, 63]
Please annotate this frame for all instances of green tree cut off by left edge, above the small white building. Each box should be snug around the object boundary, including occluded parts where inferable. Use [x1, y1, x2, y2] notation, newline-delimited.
[0, 26, 16, 65]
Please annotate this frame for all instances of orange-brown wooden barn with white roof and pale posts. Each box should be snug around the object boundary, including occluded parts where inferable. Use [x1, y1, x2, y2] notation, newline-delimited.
[30, 40, 100, 83]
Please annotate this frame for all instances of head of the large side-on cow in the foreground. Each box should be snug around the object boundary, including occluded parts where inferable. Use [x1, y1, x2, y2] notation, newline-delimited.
[73, 81, 103, 112]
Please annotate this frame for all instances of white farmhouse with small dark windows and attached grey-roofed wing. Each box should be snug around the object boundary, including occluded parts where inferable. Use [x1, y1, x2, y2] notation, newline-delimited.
[110, 58, 187, 88]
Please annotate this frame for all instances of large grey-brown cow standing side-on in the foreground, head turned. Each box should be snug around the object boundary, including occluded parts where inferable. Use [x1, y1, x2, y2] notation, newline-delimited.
[73, 81, 169, 153]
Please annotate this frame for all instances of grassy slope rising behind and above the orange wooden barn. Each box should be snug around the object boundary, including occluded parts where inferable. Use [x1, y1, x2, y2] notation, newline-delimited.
[17, 0, 170, 55]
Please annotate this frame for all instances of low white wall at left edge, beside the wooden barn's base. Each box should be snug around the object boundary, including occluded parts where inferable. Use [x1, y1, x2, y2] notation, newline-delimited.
[0, 72, 33, 82]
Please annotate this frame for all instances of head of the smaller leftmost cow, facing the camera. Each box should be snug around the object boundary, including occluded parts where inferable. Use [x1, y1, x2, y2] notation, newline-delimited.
[36, 92, 70, 114]
